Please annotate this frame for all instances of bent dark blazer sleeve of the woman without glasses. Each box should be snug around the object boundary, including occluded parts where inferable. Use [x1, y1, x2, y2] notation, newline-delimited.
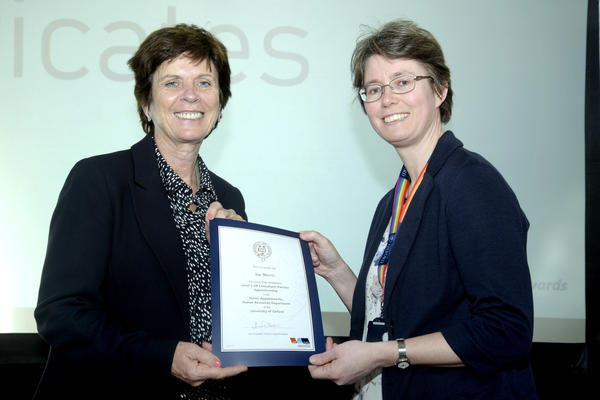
[34, 159, 177, 376]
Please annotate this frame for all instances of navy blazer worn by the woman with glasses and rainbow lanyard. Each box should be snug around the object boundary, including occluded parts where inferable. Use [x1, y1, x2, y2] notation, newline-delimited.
[350, 131, 537, 400]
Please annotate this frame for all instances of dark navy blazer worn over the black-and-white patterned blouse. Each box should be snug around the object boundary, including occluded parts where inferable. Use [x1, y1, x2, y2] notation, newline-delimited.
[35, 136, 246, 399]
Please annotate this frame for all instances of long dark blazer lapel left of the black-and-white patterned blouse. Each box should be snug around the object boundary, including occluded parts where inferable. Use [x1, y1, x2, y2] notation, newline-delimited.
[130, 136, 189, 325]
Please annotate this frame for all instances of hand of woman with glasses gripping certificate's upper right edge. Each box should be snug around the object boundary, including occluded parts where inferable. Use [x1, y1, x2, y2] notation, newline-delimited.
[300, 231, 356, 311]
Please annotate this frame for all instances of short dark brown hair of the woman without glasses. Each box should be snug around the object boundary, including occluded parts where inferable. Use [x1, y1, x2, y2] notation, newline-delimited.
[127, 24, 231, 133]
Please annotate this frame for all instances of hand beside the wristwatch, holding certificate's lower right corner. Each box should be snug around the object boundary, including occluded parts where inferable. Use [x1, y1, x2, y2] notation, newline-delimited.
[308, 338, 397, 385]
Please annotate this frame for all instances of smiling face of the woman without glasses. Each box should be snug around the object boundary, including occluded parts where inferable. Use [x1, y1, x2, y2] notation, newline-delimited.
[144, 55, 221, 146]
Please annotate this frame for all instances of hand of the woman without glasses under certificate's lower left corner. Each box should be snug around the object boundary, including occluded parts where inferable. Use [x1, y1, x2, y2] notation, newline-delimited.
[171, 342, 248, 386]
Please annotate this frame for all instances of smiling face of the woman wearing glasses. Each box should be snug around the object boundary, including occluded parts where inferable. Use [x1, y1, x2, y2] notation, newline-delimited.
[364, 55, 446, 150]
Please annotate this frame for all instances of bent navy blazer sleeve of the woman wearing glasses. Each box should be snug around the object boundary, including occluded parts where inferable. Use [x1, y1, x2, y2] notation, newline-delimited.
[442, 159, 533, 374]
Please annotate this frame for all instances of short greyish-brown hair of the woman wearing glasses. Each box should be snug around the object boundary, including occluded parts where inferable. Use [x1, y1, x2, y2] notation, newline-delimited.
[350, 19, 453, 123]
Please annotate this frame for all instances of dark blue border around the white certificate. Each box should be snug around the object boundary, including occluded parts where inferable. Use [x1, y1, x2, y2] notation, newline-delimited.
[210, 218, 325, 367]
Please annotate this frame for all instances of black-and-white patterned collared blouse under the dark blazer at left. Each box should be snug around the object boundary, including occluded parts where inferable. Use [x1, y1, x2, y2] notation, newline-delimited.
[154, 143, 226, 399]
